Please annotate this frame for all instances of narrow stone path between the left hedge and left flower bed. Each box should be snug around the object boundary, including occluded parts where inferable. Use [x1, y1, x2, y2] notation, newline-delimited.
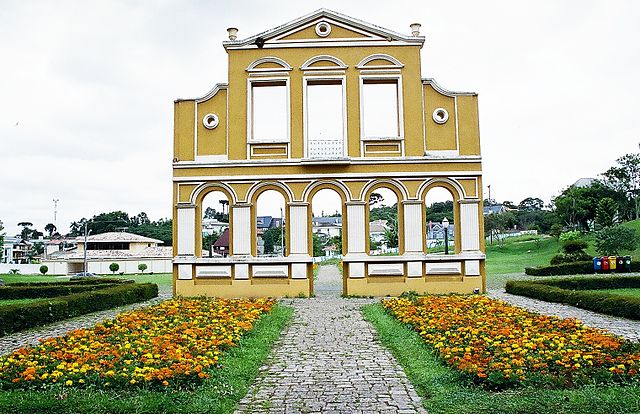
[0, 291, 172, 355]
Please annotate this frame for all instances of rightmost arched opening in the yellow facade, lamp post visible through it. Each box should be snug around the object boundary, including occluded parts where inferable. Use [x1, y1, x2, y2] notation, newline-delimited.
[425, 187, 459, 254]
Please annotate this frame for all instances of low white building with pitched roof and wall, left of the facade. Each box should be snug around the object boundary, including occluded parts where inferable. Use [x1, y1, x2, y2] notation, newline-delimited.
[42, 232, 173, 274]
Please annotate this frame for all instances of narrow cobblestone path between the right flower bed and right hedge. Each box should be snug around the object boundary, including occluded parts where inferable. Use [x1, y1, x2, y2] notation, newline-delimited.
[489, 290, 640, 342]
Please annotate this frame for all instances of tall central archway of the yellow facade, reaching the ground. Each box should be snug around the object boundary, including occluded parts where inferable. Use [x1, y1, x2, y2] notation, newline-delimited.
[311, 188, 345, 295]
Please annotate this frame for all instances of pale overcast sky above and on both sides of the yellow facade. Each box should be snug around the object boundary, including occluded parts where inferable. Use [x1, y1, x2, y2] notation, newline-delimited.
[0, 0, 640, 234]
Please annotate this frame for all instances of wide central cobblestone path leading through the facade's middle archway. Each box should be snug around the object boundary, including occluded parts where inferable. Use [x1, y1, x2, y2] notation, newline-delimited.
[237, 266, 426, 413]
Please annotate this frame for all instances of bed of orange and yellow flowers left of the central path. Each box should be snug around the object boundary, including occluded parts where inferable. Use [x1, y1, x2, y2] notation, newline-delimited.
[0, 299, 274, 389]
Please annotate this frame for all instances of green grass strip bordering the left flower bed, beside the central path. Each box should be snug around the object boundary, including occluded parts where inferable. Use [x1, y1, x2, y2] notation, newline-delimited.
[0, 305, 293, 414]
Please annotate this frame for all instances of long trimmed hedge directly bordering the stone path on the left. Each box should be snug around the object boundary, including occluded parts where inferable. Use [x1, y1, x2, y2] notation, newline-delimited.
[0, 283, 158, 336]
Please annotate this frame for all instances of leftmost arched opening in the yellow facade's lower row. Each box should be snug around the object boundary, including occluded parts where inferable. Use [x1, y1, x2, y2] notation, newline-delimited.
[200, 190, 231, 257]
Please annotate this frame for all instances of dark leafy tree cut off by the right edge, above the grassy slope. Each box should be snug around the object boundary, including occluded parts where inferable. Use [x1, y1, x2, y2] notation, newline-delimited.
[602, 153, 640, 219]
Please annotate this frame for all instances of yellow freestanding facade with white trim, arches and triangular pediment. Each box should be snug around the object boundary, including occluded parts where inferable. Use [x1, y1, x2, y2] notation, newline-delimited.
[173, 9, 485, 297]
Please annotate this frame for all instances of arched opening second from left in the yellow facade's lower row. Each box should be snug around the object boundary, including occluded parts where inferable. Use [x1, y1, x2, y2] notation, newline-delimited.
[255, 190, 287, 257]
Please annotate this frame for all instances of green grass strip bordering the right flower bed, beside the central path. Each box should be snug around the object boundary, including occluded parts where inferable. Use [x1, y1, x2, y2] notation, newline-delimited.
[363, 304, 640, 414]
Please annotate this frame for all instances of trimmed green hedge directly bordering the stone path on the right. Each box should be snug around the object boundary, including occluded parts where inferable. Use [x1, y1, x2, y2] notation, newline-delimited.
[505, 276, 640, 320]
